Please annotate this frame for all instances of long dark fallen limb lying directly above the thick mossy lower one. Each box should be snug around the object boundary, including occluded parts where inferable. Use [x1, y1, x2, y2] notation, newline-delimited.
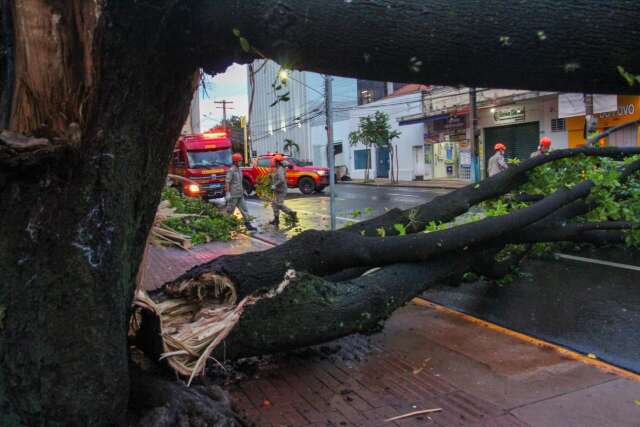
[164, 181, 593, 299]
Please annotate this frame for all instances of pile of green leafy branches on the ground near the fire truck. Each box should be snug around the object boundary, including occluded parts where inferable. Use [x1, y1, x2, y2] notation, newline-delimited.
[162, 188, 240, 245]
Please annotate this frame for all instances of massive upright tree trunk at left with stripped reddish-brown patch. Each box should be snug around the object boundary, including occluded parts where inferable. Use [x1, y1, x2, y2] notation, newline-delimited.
[0, 0, 196, 425]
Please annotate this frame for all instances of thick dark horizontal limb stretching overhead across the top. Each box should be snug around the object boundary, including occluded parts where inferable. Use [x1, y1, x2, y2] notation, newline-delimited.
[189, 0, 640, 93]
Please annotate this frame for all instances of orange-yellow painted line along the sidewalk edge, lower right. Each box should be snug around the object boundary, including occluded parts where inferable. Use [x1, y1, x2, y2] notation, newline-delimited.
[412, 297, 640, 381]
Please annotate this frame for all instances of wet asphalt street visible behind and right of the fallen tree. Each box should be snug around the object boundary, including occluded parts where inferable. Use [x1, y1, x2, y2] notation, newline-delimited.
[226, 184, 640, 372]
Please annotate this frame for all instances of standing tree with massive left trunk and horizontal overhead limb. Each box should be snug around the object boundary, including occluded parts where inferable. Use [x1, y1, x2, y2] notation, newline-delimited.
[0, 0, 640, 425]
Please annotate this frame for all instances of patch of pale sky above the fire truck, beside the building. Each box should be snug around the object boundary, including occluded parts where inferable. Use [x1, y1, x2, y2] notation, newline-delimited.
[200, 64, 249, 131]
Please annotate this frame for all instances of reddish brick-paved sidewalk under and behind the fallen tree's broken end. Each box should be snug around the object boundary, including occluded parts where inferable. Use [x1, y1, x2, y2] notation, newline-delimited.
[143, 236, 640, 427]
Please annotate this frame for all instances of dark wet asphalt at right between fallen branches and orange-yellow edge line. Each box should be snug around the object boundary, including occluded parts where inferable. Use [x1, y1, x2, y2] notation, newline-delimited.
[424, 248, 640, 373]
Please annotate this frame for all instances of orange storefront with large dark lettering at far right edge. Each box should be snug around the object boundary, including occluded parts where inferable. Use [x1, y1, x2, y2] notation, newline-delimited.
[566, 95, 640, 147]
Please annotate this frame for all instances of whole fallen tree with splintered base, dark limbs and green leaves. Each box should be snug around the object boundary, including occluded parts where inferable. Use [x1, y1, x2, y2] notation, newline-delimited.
[135, 147, 640, 381]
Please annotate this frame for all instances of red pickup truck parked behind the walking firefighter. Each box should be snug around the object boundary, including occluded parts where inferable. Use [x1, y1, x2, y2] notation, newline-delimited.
[242, 153, 329, 195]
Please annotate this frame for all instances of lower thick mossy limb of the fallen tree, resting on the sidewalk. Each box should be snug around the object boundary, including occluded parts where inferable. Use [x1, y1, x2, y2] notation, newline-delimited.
[139, 257, 470, 368]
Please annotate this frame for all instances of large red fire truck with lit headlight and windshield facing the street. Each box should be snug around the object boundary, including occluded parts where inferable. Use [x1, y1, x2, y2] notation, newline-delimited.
[169, 128, 231, 199]
